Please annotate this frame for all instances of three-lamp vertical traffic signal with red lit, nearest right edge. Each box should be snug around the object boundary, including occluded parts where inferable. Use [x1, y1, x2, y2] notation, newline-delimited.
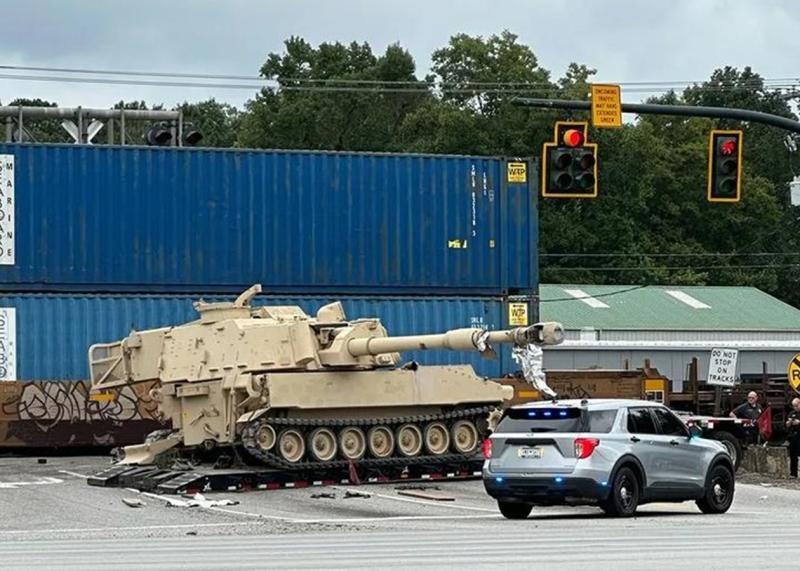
[708, 129, 742, 202]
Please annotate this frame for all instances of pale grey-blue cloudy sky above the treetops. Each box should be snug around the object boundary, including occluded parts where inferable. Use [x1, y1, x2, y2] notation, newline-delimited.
[0, 0, 800, 107]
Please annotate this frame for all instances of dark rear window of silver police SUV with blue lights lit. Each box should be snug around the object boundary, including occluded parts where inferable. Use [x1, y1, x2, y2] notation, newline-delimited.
[497, 407, 617, 433]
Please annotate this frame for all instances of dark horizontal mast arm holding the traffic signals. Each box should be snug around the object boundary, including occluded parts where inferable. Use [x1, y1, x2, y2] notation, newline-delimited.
[513, 97, 800, 134]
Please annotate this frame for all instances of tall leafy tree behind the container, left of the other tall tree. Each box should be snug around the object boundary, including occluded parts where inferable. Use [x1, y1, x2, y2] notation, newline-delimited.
[238, 37, 430, 151]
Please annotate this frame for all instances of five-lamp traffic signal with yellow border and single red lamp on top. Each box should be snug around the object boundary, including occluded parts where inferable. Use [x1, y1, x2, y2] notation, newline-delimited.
[542, 121, 597, 198]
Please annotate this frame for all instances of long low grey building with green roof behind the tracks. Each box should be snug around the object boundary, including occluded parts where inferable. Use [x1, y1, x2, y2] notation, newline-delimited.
[539, 284, 800, 384]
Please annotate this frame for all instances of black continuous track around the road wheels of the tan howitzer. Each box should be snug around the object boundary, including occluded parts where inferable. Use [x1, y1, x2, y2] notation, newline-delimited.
[242, 405, 496, 472]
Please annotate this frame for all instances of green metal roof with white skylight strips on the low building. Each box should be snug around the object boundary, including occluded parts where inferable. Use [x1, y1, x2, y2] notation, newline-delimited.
[539, 284, 800, 331]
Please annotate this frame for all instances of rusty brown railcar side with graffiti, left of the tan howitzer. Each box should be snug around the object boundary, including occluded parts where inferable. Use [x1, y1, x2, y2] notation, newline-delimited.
[0, 381, 163, 448]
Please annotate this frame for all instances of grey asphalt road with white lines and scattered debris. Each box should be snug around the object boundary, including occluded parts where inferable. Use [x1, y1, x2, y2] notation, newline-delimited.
[0, 458, 800, 570]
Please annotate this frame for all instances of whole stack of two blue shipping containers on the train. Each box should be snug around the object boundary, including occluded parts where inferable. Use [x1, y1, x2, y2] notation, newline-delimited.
[0, 144, 538, 380]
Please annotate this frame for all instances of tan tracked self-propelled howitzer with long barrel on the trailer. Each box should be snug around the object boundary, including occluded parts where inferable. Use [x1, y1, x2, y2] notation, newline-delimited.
[89, 285, 563, 469]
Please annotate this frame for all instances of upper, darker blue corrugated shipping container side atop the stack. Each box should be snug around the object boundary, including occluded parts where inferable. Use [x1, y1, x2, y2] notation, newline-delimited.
[0, 144, 538, 296]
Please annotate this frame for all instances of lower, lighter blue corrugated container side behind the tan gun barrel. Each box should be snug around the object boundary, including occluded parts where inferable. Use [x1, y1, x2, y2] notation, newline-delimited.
[0, 294, 509, 380]
